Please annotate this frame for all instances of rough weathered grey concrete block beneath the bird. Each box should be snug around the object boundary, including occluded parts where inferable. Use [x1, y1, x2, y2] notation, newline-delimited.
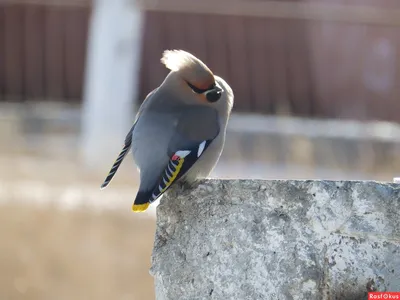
[151, 180, 400, 300]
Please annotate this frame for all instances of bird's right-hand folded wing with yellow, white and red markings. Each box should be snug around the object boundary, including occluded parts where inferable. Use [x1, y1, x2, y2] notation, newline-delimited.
[132, 106, 220, 211]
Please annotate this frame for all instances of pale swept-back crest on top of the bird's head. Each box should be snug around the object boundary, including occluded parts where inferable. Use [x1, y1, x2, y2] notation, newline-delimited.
[161, 50, 215, 89]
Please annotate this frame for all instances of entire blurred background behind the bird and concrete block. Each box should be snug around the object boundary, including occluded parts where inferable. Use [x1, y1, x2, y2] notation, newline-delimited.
[0, 0, 400, 300]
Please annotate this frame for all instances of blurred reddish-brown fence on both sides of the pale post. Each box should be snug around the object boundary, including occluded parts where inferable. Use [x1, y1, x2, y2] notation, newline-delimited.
[0, 0, 400, 122]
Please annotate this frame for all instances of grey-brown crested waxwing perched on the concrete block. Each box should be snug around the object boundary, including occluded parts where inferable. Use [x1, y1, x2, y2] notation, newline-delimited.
[101, 49, 234, 212]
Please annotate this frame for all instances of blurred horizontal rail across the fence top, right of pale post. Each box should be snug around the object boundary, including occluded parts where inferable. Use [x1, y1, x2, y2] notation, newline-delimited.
[139, 0, 400, 26]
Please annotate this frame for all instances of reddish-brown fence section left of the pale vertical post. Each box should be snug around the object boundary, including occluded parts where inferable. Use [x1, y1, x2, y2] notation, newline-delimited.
[0, 3, 90, 101]
